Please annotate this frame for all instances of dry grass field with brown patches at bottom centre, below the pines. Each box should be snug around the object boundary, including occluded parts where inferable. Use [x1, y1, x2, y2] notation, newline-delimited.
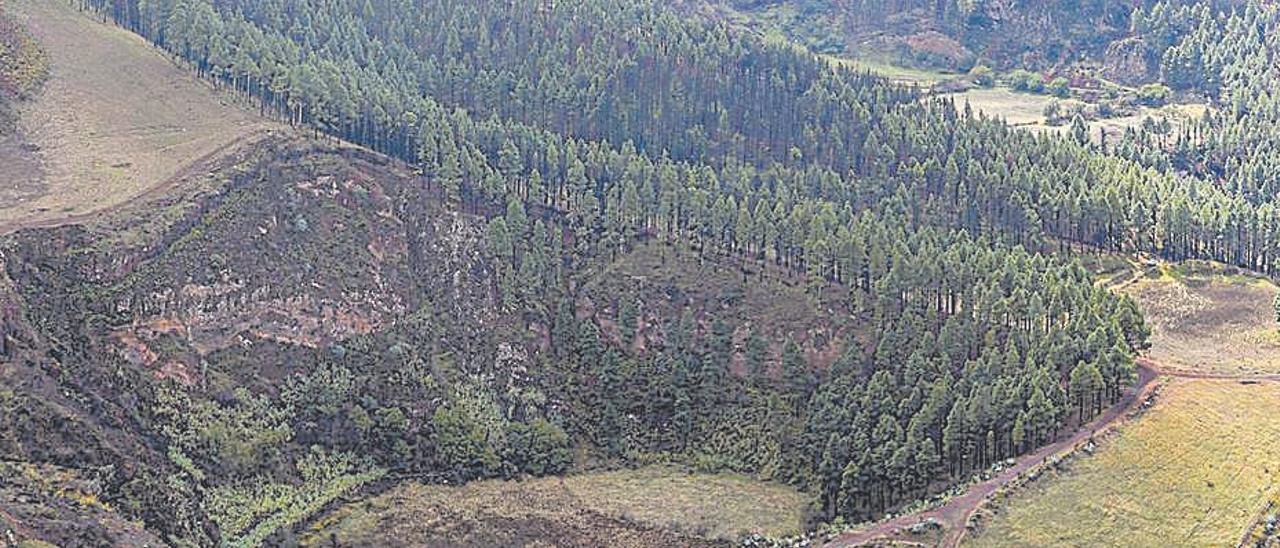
[302, 466, 806, 547]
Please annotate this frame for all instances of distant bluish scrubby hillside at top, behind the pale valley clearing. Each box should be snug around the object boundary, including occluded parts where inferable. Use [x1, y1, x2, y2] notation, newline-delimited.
[682, 0, 1247, 73]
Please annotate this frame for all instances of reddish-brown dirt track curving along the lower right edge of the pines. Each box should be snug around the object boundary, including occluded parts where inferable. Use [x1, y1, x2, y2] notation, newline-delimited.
[826, 357, 1280, 548]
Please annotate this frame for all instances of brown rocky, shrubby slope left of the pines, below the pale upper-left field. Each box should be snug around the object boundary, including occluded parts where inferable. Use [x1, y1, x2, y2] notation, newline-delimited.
[0, 141, 490, 539]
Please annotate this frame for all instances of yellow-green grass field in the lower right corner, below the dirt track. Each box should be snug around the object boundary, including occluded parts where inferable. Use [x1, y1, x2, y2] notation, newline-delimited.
[968, 378, 1280, 547]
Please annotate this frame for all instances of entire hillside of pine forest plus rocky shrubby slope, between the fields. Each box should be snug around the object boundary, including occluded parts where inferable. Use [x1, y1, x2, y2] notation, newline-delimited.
[0, 0, 1177, 545]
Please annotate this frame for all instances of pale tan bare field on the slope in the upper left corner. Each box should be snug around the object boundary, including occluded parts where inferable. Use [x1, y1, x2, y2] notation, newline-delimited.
[0, 0, 273, 232]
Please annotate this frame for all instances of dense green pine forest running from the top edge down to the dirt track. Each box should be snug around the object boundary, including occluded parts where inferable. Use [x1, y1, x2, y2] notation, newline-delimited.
[24, 0, 1228, 540]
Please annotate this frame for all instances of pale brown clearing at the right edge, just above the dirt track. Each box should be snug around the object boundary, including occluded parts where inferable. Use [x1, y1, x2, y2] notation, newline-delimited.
[1121, 261, 1280, 375]
